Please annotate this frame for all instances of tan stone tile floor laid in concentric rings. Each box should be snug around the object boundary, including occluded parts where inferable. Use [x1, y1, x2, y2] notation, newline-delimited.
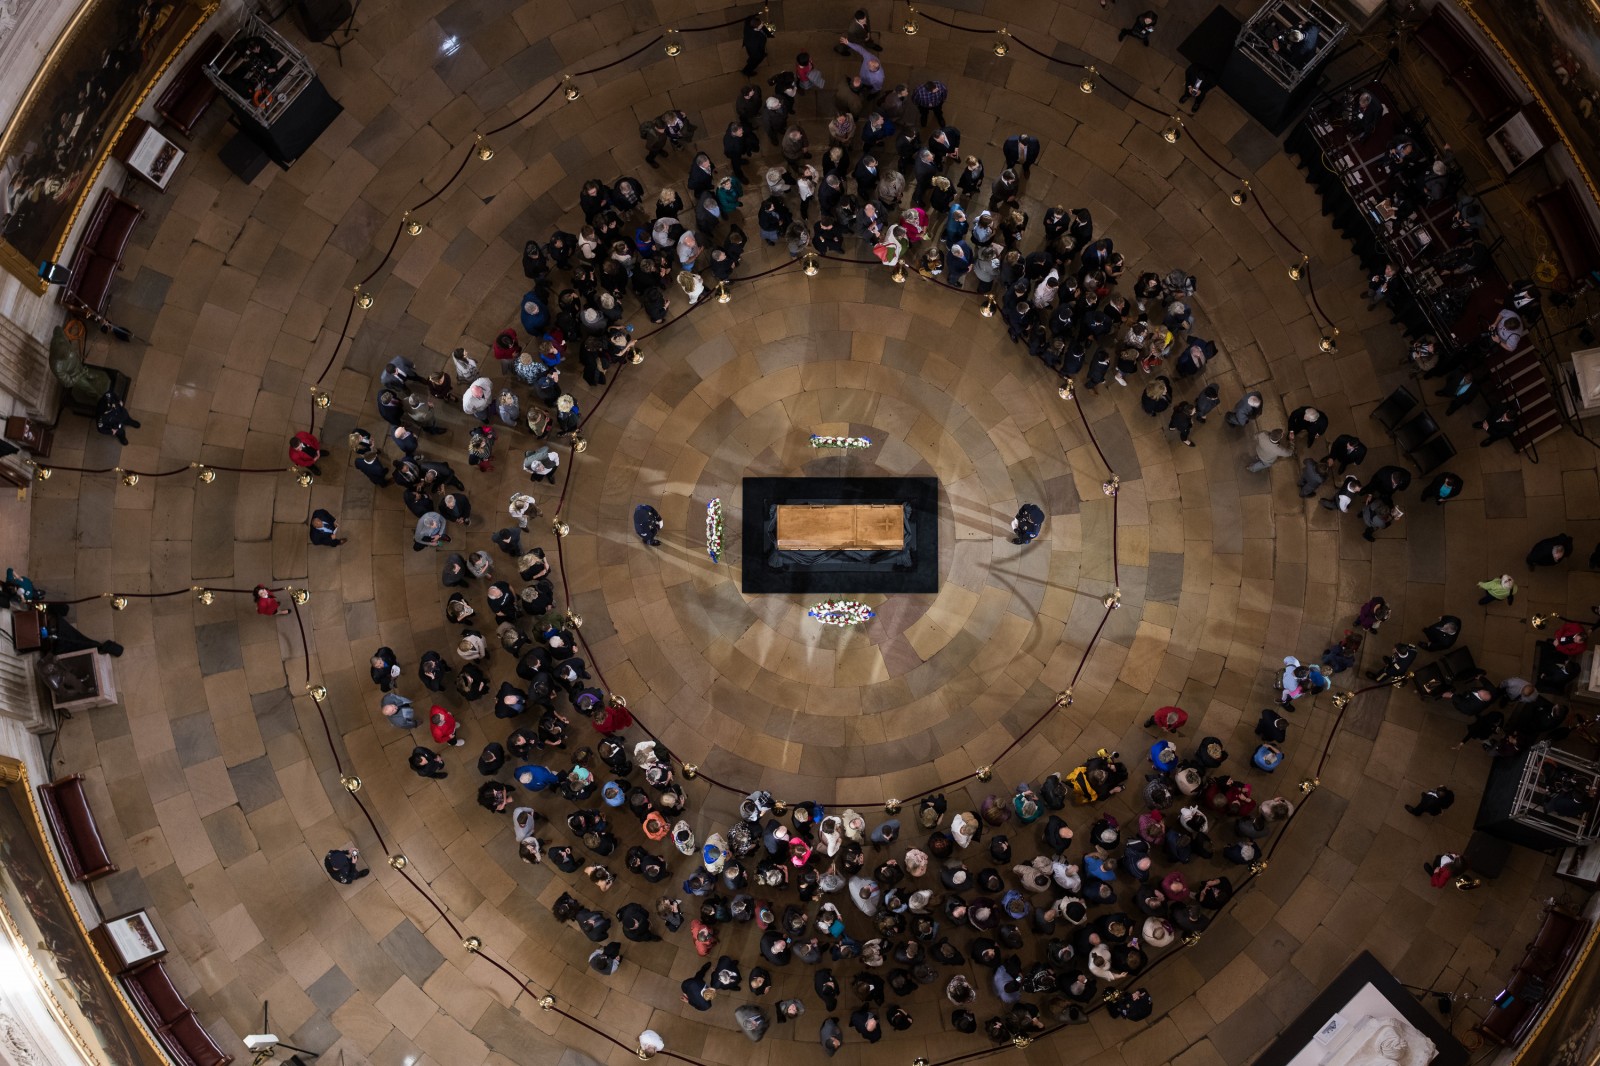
[21, 0, 1600, 1066]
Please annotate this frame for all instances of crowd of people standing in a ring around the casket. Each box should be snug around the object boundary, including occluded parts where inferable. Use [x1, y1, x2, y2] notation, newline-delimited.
[291, 13, 1600, 1055]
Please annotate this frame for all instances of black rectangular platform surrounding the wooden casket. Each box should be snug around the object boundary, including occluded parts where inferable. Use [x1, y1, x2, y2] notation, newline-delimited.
[739, 477, 939, 594]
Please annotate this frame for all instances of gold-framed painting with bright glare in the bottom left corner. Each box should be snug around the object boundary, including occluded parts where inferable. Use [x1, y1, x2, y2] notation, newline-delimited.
[0, 759, 166, 1066]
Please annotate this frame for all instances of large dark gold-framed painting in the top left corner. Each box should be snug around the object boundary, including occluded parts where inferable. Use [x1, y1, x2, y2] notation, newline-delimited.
[0, 0, 218, 293]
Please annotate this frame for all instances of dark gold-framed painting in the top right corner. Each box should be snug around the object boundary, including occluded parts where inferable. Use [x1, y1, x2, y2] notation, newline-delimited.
[1456, 0, 1600, 202]
